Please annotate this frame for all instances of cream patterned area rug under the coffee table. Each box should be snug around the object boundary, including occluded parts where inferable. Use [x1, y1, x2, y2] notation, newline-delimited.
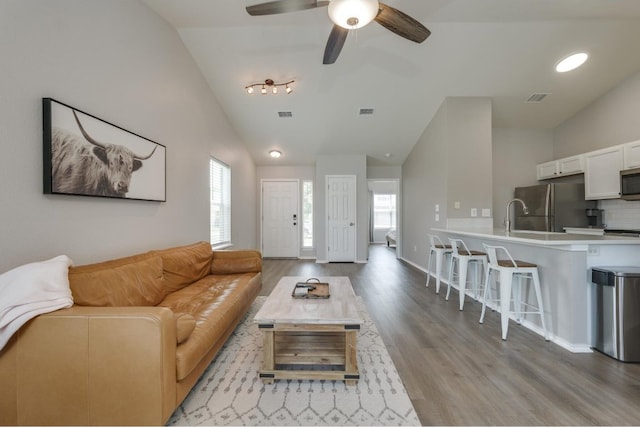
[169, 297, 420, 426]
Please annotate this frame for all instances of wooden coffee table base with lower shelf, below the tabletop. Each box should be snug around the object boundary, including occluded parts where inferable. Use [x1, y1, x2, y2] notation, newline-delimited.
[258, 323, 360, 385]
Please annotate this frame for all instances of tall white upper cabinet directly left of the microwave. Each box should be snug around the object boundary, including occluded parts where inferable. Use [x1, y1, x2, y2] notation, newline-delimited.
[584, 145, 623, 200]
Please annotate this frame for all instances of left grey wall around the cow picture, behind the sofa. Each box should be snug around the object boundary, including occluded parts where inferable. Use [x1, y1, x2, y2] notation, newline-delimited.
[0, 0, 257, 271]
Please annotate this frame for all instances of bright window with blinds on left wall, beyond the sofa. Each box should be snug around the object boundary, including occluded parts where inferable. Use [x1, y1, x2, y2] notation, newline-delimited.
[209, 158, 231, 246]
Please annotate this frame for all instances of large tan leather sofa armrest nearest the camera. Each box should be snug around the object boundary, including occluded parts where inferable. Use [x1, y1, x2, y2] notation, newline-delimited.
[0, 306, 176, 425]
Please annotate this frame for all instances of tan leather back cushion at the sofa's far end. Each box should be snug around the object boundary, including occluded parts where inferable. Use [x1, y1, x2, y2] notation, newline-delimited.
[153, 242, 212, 294]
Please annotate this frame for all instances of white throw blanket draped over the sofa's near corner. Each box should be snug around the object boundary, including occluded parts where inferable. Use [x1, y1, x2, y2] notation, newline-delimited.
[0, 255, 73, 350]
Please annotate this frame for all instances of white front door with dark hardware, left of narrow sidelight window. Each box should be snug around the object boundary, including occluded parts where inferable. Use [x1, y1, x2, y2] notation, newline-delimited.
[262, 181, 299, 258]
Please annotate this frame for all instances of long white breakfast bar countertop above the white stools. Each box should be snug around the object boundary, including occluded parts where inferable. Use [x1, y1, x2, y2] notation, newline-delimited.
[433, 228, 640, 246]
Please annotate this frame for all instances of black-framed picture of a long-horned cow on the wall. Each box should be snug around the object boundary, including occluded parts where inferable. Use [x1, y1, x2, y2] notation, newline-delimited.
[42, 98, 166, 202]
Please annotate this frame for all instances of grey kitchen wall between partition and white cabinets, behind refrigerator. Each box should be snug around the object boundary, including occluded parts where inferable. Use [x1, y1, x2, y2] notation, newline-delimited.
[493, 128, 553, 228]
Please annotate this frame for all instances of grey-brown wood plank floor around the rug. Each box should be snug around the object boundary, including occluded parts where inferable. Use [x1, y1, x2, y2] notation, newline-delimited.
[262, 246, 640, 425]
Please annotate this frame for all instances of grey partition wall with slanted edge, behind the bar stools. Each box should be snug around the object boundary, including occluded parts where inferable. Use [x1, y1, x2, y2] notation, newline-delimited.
[402, 98, 493, 267]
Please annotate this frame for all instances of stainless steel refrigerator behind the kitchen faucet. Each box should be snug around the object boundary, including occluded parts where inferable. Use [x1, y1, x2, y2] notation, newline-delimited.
[513, 183, 596, 232]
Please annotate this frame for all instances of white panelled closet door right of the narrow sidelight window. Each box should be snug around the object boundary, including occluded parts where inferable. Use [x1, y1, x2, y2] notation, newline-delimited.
[327, 175, 356, 262]
